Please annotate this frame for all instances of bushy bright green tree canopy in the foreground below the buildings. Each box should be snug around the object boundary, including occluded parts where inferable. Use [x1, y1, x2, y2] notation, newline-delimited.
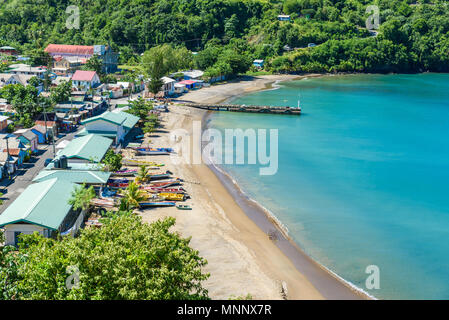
[0, 214, 209, 300]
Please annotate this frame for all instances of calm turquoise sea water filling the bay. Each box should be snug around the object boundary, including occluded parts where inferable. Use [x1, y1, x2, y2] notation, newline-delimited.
[211, 74, 449, 299]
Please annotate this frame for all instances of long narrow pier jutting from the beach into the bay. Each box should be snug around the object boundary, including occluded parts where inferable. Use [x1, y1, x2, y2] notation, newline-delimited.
[179, 102, 301, 115]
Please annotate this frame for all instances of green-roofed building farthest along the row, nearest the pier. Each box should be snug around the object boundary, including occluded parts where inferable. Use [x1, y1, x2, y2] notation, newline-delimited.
[78, 111, 139, 145]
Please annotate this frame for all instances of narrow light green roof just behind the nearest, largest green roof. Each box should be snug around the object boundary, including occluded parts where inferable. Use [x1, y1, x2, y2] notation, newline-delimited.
[33, 170, 111, 184]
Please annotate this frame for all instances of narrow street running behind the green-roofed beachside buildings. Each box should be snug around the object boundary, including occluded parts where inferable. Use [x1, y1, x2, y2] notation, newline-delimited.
[0, 132, 76, 214]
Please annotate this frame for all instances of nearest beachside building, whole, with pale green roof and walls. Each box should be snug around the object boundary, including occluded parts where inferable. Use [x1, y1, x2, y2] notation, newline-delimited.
[0, 178, 84, 245]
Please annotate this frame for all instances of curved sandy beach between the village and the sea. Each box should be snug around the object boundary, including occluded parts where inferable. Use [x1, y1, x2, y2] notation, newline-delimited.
[132, 75, 366, 299]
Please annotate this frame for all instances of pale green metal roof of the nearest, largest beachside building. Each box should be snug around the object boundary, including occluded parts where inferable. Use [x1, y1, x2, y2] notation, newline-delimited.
[0, 179, 76, 230]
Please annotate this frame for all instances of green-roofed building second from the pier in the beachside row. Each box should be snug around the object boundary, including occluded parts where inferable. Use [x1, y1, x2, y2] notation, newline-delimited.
[57, 134, 112, 165]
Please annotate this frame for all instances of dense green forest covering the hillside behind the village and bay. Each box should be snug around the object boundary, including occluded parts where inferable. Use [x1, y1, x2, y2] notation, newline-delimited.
[0, 0, 449, 76]
